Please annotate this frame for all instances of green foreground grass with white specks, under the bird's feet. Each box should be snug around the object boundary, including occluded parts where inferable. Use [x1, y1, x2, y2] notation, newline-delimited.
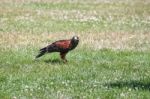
[0, 49, 150, 99]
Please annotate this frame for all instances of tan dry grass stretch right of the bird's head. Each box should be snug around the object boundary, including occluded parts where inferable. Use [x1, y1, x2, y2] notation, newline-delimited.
[82, 32, 150, 50]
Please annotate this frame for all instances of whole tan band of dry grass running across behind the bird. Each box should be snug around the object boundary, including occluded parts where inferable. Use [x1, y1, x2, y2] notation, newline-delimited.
[0, 32, 150, 50]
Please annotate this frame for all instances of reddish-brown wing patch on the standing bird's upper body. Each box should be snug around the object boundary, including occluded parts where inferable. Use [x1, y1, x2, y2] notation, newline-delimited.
[53, 40, 71, 49]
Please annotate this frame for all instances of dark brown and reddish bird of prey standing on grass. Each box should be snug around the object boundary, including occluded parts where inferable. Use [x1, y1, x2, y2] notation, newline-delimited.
[36, 36, 79, 62]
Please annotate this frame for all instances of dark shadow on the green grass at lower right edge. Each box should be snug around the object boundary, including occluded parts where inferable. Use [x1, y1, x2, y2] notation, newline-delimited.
[104, 80, 150, 91]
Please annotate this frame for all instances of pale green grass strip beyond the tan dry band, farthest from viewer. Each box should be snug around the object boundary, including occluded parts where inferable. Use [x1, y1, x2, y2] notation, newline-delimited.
[0, 2, 150, 33]
